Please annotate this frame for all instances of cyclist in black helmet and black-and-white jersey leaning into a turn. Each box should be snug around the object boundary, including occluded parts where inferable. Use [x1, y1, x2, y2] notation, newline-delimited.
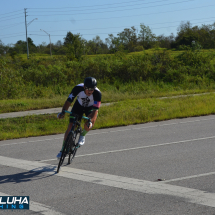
[57, 77, 102, 159]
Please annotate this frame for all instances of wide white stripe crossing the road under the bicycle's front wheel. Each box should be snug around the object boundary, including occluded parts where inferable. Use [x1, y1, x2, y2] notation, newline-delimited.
[0, 156, 215, 207]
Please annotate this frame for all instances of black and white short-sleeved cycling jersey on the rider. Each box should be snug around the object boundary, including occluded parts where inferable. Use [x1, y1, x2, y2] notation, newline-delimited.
[67, 83, 102, 110]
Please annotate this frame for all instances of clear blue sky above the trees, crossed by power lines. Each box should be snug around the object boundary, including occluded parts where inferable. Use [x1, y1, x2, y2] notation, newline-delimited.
[0, 0, 215, 45]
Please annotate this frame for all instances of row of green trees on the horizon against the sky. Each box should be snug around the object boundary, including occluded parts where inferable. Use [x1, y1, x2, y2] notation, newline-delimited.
[0, 21, 215, 60]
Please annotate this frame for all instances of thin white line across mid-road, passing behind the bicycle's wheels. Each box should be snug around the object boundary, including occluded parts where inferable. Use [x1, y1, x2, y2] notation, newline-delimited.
[39, 136, 215, 162]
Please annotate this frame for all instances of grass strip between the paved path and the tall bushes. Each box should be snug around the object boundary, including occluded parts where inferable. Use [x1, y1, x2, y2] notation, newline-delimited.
[0, 82, 215, 113]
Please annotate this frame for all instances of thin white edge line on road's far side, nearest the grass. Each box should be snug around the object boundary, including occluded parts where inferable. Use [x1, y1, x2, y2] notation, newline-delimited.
[0, 118, 215, 147]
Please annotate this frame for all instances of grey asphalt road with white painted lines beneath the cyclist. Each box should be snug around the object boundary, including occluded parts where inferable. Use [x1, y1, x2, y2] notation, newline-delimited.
[0, 115, 215, 215]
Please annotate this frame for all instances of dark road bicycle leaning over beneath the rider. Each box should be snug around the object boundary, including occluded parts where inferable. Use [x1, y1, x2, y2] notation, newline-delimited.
[57, 111, 91, 173]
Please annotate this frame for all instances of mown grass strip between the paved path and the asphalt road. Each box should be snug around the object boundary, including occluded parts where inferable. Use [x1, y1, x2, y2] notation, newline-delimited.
[0, 94, 215, 140]
